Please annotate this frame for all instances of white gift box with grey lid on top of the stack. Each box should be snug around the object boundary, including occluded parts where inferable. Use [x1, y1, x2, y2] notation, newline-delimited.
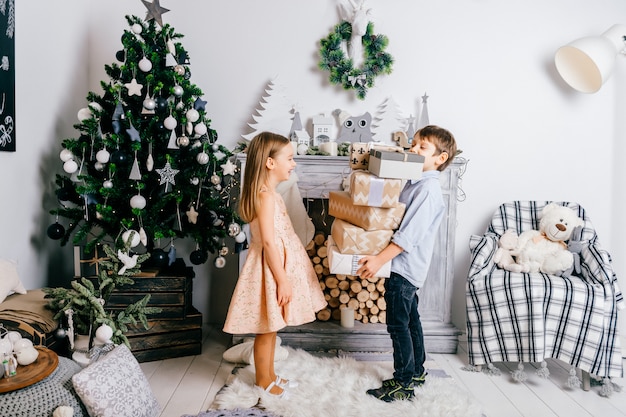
[367, 149, 424, 180]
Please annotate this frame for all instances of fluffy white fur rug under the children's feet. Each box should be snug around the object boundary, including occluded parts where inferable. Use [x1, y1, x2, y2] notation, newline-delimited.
[211, 348, 482, 417]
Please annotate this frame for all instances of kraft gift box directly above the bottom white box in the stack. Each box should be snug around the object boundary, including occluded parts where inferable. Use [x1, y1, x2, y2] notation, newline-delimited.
[330, 219, 393, 255]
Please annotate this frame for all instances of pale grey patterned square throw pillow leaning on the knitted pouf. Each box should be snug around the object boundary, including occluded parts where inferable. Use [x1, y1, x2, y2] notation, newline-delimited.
[72, 344, 161, 417]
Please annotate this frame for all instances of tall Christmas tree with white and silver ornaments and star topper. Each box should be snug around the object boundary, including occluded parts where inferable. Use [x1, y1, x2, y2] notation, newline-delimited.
[48, 4, 241, 266]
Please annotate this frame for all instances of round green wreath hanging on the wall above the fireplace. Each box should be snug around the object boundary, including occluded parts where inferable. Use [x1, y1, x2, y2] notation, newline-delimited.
[318, 21, 393, 100]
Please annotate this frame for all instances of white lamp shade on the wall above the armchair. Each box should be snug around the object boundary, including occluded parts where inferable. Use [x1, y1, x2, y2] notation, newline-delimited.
[554, 25, 626, 93]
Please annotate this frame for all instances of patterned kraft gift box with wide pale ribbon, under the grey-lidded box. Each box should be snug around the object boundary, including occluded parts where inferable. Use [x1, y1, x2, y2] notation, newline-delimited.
[350, 170, 402, 207]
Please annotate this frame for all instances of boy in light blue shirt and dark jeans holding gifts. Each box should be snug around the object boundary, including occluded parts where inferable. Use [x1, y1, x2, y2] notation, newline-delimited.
[356, 125, 456, 402]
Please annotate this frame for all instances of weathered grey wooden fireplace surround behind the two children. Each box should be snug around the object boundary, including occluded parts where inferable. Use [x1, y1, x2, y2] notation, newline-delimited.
[234, 154, 465, 358]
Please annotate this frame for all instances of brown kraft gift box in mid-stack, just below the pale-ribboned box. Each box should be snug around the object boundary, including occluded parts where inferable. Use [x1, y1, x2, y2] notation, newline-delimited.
[328, 191, 406, 230]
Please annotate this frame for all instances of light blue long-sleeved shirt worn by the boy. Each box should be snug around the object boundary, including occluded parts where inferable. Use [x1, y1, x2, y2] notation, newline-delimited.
[391, 170, 446, 288]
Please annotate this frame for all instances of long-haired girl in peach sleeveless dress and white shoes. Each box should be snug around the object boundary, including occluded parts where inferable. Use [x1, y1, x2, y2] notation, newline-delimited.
[224, 132, 326, 396]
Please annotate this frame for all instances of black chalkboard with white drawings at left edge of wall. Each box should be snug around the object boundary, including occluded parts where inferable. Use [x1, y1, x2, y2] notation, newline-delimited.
[0, 0, 15, 152]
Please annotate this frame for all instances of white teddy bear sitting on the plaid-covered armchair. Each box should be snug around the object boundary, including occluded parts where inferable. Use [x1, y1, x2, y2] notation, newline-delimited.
[503, 203, 584, 275]
